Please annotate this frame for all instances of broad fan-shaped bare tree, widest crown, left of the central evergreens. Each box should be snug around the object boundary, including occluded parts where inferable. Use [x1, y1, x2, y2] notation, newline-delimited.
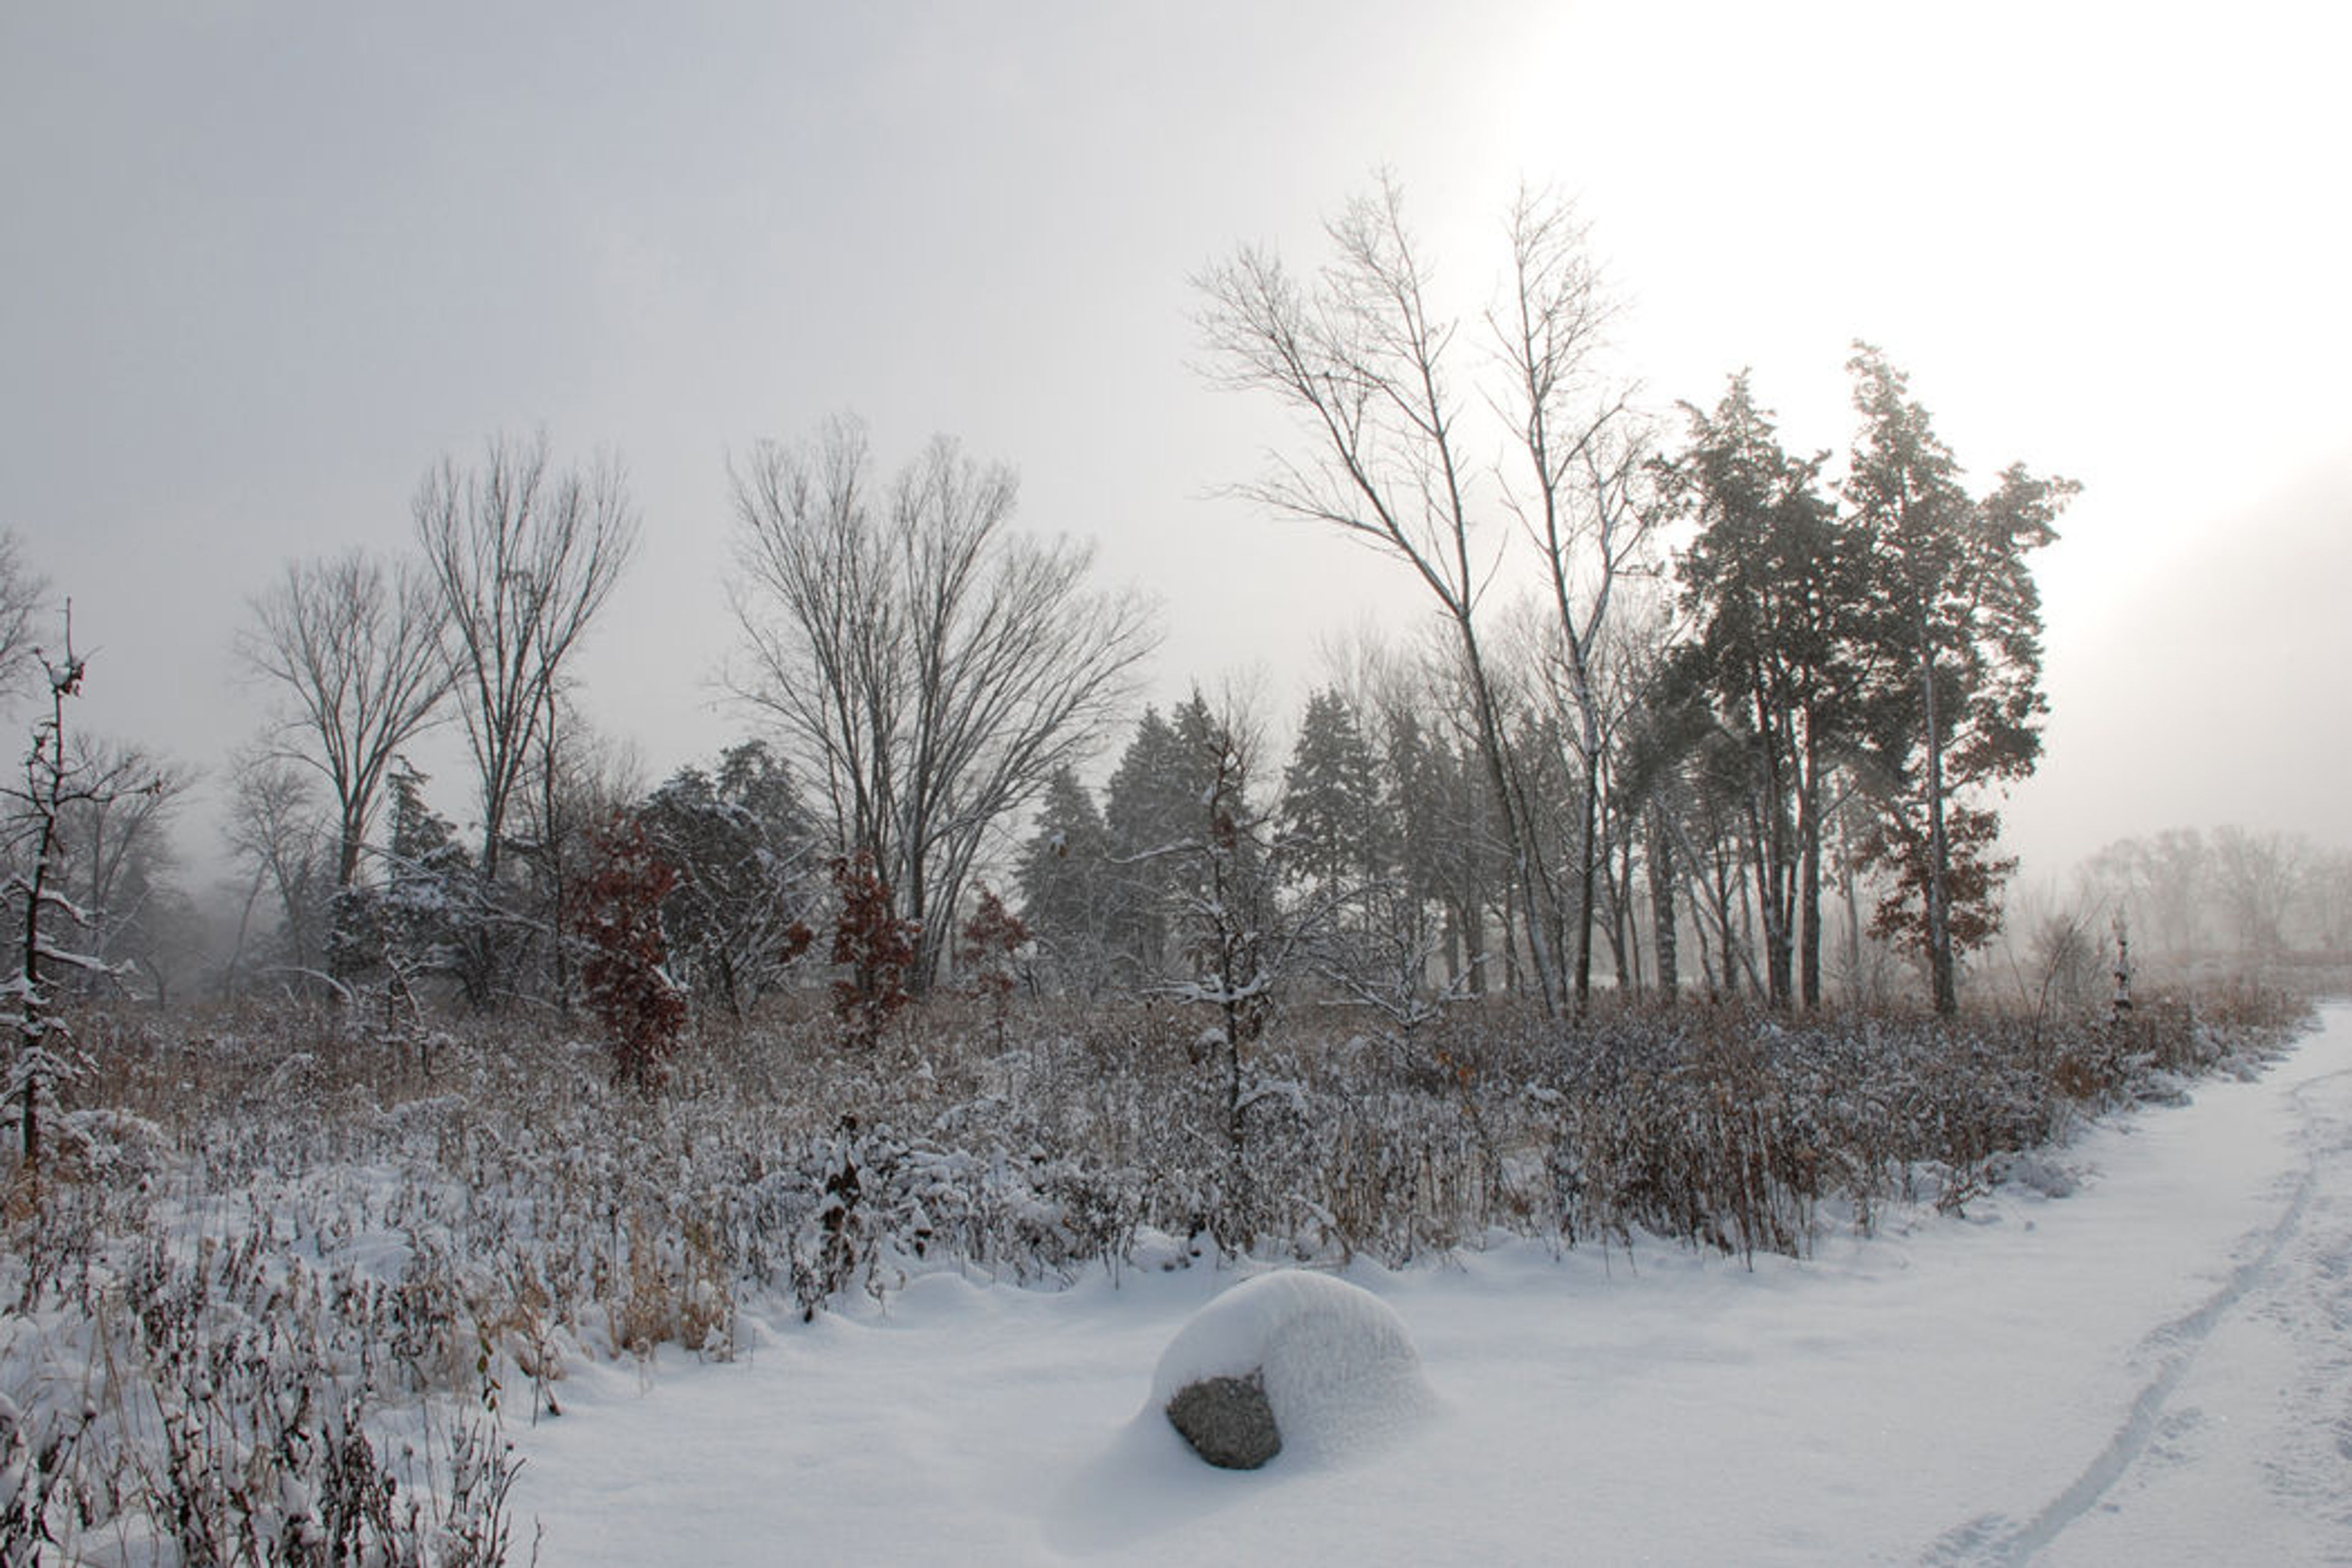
[731, 421, 1155, 992]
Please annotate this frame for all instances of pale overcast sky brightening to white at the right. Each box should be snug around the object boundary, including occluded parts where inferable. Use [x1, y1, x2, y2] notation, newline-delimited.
[0, 0, 2352, 893]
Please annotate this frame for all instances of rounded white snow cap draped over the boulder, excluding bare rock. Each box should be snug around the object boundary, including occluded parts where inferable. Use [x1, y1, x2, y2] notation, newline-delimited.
[1136, 1270, 1433, 1460]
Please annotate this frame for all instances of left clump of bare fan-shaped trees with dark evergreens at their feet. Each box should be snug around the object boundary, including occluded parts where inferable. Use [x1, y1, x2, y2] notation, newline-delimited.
[209, 421, 1153, 1030]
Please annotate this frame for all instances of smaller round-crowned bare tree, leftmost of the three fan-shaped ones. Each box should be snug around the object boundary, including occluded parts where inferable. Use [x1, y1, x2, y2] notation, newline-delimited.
[238, 550, 451, 891]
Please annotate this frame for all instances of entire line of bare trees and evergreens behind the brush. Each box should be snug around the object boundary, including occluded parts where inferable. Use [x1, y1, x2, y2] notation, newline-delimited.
[28, 183, 2314, 1109]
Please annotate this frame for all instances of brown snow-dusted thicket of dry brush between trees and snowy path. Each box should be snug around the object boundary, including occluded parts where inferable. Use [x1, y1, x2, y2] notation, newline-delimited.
[0, 987, 2305, 1563]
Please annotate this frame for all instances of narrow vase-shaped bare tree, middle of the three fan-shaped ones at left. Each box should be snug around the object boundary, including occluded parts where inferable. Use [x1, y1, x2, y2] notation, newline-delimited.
[417, 435, 638, 881]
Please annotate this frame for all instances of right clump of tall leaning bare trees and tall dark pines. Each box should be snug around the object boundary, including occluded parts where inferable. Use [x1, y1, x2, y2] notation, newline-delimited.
[1199, 183, 2075, 1013]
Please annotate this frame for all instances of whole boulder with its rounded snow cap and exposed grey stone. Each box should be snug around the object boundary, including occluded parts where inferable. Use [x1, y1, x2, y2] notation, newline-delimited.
[1150, 1270, 1434, 1469]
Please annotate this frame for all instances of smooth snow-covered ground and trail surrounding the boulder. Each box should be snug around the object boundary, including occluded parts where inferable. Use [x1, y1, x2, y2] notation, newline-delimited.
[513, 1006, 2352, 1566]
